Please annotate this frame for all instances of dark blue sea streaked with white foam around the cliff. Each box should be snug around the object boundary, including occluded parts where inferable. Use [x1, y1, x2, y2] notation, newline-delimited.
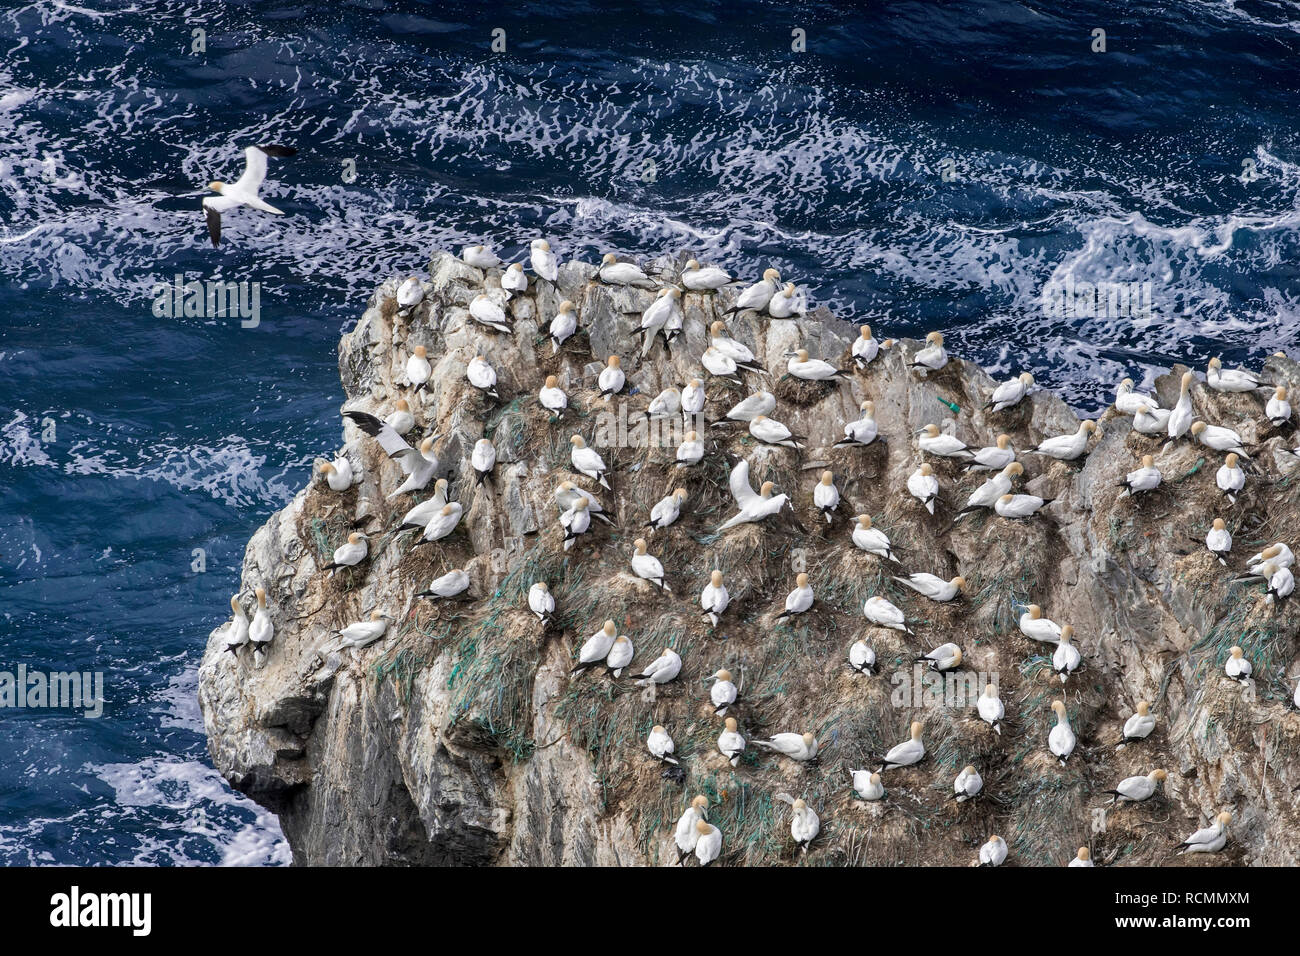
[0, 0, 1300, 865]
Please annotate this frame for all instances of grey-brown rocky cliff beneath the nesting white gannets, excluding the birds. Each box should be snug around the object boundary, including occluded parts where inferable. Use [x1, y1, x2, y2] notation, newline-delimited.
[199, 255, 1300, 865]
